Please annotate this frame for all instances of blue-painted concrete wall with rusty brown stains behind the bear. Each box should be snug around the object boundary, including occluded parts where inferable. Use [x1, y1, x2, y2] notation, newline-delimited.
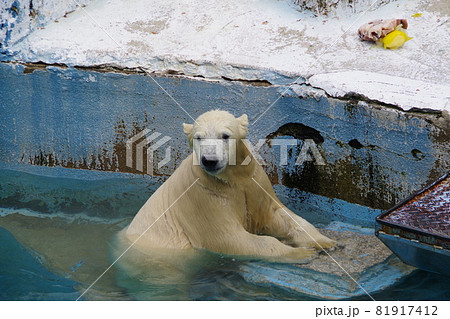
[0, 63, 450, 220]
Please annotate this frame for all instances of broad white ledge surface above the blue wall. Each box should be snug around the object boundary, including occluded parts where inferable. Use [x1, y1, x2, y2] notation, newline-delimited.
[3, 0, 450, 110]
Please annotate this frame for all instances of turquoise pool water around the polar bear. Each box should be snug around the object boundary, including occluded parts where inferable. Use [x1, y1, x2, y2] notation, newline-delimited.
[0, 167, 450, 300]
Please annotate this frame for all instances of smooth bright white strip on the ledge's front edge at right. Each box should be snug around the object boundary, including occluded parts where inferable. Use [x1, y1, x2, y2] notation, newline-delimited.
[309, 71, 450, 112]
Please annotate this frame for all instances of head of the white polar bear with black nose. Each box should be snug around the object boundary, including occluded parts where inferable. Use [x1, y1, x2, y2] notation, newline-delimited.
[183, 110, 248, 175]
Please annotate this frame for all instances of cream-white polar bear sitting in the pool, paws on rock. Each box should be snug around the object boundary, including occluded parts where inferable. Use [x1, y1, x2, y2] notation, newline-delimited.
[123, 110, 335, 262]
